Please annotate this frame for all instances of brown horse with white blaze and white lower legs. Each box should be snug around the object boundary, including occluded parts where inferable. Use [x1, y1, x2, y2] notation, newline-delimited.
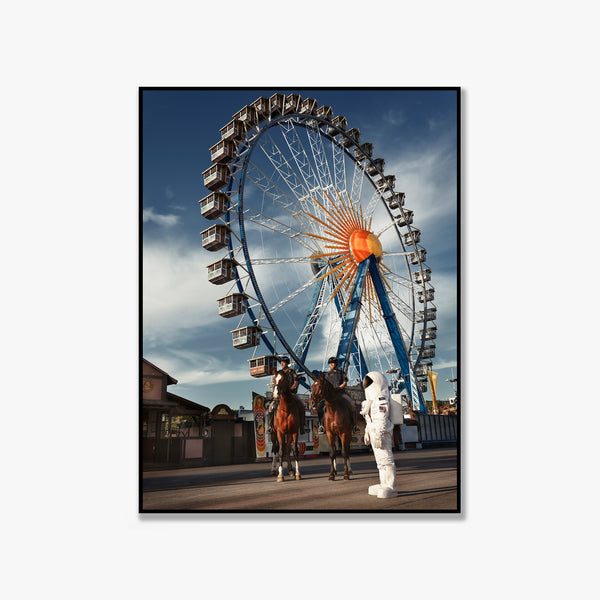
[271, 371, 304, 481]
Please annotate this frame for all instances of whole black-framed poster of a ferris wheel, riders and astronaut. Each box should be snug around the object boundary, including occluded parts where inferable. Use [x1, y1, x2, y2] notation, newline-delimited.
[139, 87, 461, 513]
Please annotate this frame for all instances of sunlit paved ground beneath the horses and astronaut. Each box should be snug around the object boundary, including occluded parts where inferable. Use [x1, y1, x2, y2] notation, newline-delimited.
[142, 448, 458, 512]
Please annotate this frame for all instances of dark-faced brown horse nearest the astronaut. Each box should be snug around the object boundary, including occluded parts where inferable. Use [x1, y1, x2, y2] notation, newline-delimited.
[310, 374, 356, 481]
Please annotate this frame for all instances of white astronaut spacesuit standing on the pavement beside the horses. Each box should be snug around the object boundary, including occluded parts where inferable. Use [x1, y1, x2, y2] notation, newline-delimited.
[360, 371, 397, 498]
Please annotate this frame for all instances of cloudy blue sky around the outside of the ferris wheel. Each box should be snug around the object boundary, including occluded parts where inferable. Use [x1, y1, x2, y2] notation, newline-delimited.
[142, 89, 457, 408]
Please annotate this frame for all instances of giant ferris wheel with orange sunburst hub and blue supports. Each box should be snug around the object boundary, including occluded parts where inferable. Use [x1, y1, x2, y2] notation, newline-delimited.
[200, 93, 437, 412]
